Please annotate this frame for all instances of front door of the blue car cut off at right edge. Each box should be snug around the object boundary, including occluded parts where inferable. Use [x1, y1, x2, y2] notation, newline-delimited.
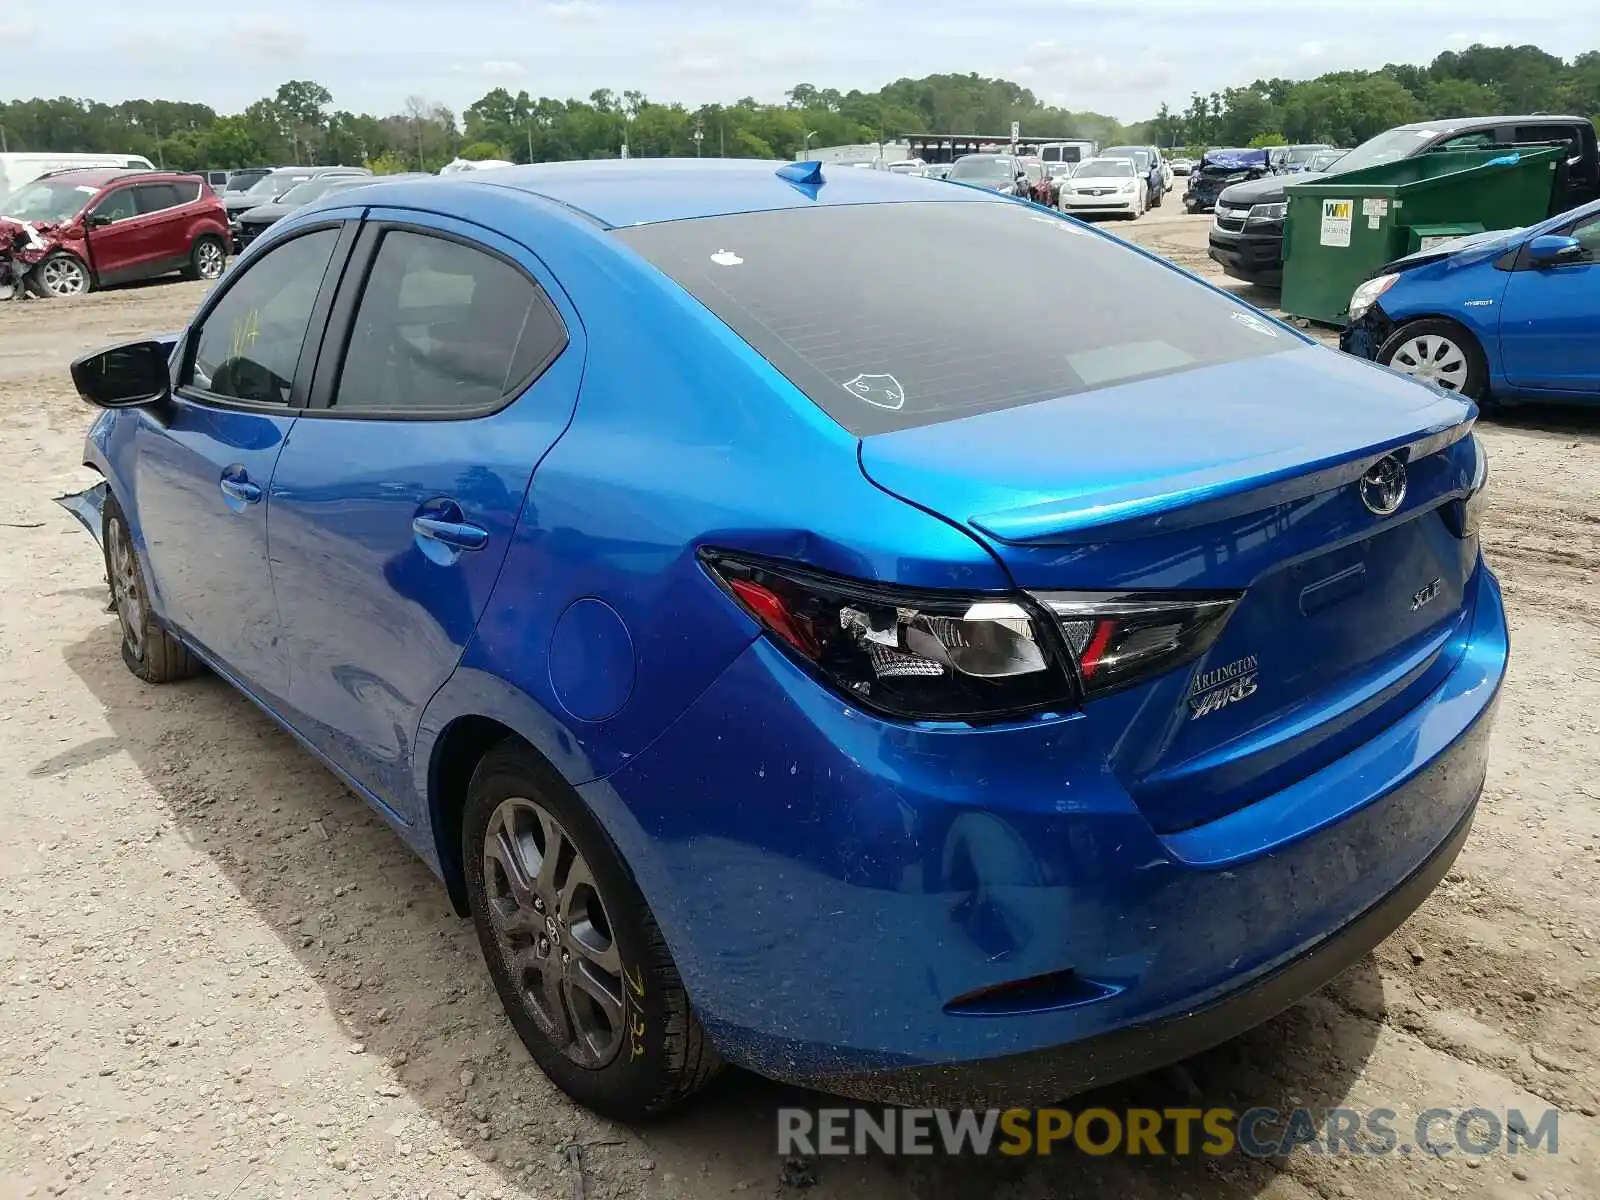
[1499, 216, 1600, 392]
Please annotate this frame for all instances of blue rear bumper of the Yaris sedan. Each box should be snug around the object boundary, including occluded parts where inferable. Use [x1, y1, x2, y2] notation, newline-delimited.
[581, 565, 1509, 1106]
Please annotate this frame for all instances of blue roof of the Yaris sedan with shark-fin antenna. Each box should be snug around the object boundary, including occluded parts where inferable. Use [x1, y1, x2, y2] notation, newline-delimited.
[444, 155, 995, 227]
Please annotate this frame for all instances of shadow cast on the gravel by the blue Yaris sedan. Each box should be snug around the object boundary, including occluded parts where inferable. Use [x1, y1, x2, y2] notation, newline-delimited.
[65, 630, 1384, 1200]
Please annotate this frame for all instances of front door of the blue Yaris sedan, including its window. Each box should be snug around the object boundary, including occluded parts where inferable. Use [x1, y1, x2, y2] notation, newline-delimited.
[134, 224, 353, 704]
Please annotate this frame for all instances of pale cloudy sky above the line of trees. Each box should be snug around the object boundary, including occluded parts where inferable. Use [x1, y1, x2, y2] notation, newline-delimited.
[12, 0, 1600, 120]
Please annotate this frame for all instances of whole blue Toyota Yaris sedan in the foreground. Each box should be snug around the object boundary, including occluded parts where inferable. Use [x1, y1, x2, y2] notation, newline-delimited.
[67, 160, 1509, 1117]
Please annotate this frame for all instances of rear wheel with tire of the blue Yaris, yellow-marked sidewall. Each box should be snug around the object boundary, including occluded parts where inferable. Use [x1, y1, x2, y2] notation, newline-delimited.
[461, 741, 722, 1122]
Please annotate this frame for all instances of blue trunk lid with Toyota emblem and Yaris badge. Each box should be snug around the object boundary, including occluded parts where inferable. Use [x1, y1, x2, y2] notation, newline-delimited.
[861, 347, 1477, 832]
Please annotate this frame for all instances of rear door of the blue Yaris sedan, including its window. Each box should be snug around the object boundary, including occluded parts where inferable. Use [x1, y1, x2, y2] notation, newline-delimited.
[270, 211, 582, 821]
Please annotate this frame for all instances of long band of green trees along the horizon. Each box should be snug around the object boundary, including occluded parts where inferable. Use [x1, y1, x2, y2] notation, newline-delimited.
[0, 45, 1600, 171]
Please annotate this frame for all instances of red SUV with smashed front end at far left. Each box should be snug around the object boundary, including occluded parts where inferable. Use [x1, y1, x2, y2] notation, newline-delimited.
[0, 168, 230, 296]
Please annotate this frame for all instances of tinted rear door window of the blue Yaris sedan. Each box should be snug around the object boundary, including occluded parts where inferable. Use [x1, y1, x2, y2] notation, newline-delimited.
[333, 229, 566, 416]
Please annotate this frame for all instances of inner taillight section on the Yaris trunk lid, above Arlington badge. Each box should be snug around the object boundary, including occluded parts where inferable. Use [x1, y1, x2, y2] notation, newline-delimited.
[1034, 592, 1238, 699]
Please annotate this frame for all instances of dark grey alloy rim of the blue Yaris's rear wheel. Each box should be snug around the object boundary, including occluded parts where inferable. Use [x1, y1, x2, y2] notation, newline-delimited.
[483, 797, 627, 1070]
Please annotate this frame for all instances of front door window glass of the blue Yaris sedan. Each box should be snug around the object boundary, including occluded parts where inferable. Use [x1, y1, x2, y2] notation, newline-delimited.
[184, 229, 339, 405]
